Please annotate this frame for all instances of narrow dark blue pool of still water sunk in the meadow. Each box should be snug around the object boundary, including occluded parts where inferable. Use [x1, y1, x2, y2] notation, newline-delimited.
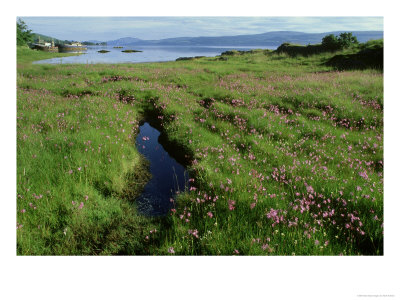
[136, 123, 188, 216]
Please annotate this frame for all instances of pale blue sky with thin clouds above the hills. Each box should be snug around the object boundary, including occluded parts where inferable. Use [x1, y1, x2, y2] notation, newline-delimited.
[20, 16, 383, 41]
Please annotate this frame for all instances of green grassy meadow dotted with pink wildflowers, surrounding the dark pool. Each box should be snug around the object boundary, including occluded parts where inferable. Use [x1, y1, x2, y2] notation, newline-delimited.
[17, 45, 383, 255]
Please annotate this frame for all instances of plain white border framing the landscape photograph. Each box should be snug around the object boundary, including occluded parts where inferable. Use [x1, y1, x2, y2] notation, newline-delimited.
[0, 0, 400, 299]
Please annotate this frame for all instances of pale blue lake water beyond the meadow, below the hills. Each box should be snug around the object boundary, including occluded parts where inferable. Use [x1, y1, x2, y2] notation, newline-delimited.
[34, 46, 276, 64]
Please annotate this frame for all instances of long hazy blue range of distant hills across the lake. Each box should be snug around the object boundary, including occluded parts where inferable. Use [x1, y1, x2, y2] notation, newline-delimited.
[107, 31, 383, 46]
